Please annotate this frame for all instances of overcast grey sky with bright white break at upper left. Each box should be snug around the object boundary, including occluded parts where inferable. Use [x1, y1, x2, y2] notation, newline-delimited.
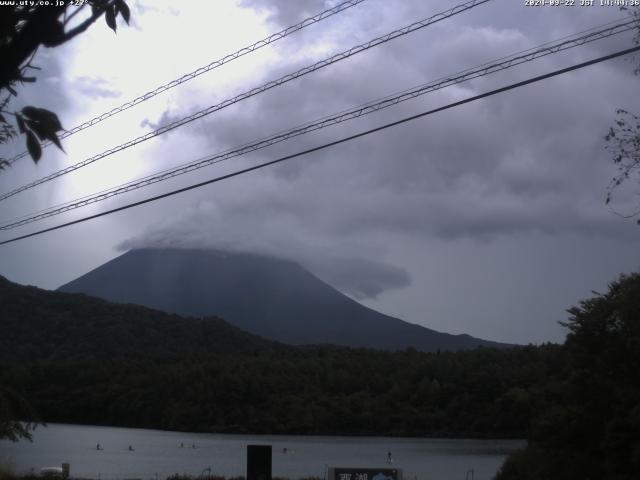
[0, 0, 640, 343]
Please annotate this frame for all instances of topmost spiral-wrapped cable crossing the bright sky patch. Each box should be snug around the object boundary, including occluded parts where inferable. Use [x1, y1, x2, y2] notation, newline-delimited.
[9, 0, 365, 164]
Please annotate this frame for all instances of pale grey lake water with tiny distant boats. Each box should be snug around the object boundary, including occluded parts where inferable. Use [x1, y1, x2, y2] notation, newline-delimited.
[0, 424, 524, 480]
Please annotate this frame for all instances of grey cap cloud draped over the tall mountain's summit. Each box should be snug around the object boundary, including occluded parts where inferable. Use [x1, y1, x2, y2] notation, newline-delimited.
[118, 202, 411, 299]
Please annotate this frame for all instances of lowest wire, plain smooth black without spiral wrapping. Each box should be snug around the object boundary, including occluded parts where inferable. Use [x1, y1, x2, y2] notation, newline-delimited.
[0, 46, 640, 249]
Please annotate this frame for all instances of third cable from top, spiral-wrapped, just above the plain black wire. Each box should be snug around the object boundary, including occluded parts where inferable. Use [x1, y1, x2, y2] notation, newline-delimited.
[0, 19, 637, 231]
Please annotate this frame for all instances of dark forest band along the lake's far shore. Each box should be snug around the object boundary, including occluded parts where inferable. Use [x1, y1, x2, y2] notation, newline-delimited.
[0, 345, 564, 438]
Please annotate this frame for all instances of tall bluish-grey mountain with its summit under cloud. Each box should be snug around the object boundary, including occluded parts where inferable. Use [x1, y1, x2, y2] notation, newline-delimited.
[59, 249, 510, 351]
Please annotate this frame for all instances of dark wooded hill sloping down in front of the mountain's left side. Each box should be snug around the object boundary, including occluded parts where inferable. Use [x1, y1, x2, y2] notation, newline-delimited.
[0, 276, 281, 361]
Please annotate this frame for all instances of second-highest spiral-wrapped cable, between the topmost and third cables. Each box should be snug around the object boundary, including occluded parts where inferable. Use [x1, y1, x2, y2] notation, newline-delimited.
[0, 0, 491, 201]
